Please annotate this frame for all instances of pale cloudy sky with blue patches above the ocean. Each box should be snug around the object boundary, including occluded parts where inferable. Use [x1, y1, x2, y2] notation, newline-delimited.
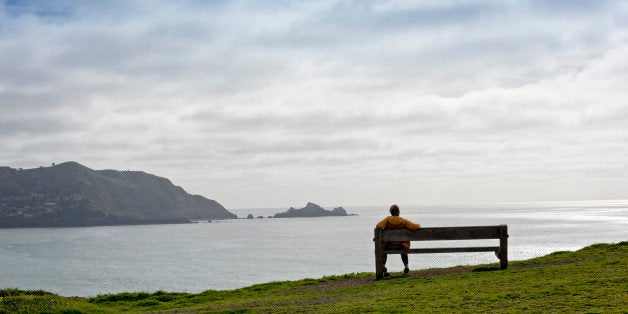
[0, 0, 628, 209]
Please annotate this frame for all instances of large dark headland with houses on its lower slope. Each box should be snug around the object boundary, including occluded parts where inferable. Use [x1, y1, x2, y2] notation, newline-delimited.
[0, 162, 236, 227]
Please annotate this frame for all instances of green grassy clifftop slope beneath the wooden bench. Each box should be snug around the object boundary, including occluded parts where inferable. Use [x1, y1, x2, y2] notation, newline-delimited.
[0, 242, 628, 313]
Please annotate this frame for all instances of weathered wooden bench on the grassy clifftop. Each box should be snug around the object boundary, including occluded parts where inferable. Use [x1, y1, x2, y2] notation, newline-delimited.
[373, 225, 508, 279]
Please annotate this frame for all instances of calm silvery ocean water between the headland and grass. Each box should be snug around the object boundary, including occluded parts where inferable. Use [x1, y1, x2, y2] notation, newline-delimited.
[0, 201, 628, 296]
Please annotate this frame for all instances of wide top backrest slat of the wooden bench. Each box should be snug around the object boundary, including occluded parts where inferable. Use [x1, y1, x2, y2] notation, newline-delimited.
[382, 226, 500, 241]
